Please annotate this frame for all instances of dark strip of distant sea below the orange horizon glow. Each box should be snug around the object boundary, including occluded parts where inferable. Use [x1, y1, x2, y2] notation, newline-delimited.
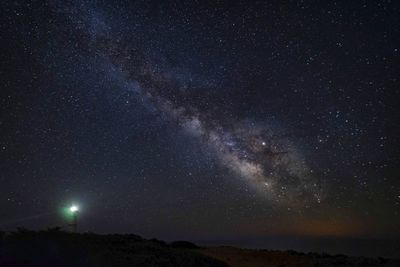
[194, 237, 400, 259]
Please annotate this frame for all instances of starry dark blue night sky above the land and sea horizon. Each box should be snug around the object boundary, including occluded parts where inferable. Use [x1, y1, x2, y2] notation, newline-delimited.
[0, 0, 400, 243]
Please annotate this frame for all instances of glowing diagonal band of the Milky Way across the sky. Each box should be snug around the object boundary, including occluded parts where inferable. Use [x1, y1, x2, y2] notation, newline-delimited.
[53, 2, 323, 207]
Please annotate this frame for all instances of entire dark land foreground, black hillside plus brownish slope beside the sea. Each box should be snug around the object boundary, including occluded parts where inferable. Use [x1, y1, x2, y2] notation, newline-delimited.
[0, 228, 400, 267]
